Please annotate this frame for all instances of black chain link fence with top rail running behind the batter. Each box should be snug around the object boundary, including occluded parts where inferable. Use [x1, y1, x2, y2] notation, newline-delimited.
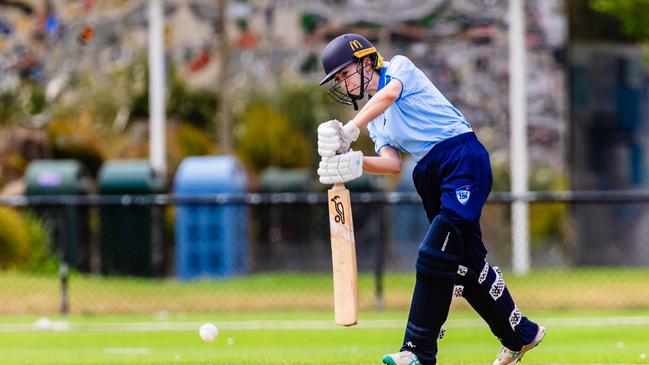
[0, 192, 649, 315]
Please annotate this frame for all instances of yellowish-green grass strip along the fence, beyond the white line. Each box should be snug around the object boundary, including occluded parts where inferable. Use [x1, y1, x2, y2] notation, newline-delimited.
[0, 268, 649, 315]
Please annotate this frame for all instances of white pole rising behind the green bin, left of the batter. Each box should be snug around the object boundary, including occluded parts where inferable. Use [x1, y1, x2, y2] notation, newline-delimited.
[149, 0, 167, 177]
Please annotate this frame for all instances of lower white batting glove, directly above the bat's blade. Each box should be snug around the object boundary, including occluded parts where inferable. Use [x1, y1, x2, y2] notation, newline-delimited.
[318, 151, 363, 184]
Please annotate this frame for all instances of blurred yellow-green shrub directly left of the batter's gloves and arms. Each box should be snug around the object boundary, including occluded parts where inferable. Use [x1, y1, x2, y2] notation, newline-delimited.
[233, 81, 352, 171]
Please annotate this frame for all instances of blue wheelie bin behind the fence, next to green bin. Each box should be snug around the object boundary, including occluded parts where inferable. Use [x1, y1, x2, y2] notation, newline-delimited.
[174, 156, 248, 280]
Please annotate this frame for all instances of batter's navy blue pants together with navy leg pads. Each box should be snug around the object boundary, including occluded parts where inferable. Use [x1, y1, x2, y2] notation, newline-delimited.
[402, 132, 538, 364]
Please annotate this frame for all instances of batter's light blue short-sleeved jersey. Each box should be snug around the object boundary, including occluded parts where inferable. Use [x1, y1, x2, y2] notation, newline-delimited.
[367, 56, 472, 161]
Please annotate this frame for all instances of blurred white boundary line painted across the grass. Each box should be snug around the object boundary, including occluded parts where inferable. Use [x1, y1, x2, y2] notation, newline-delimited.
[0, 316, 649, 333]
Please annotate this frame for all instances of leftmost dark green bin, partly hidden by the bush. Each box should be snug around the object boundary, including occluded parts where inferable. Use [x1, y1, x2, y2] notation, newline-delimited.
[25, 160, 92, 272]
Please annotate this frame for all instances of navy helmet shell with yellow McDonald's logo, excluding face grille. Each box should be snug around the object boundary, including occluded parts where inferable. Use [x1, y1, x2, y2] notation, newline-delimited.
[320, 33, 383, 85]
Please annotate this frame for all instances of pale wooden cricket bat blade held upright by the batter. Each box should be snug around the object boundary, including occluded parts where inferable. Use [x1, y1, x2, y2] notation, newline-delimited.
[328, 184, 358, 326]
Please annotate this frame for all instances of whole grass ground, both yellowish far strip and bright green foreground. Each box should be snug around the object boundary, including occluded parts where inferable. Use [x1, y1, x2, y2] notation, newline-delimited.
[0, 268, 649, 365]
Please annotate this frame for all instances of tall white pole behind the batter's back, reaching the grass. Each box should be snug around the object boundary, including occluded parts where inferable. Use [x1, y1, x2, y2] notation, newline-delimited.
[509, 0, 530, 274]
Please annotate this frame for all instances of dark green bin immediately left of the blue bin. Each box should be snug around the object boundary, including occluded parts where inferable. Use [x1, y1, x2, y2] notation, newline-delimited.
[98, 160, 165, 276]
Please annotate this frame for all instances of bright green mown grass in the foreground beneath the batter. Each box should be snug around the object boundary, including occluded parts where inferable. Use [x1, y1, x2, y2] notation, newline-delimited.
[0, 310, 649, 365]
